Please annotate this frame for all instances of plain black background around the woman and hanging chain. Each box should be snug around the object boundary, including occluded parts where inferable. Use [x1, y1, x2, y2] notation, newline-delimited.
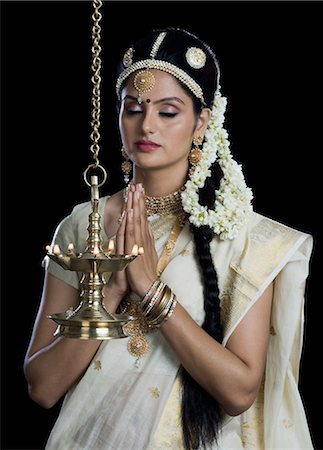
[1, 1, 323, 449]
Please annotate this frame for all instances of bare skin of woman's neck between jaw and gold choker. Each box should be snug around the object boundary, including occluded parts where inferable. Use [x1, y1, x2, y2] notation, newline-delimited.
[133, 163, 188, 197]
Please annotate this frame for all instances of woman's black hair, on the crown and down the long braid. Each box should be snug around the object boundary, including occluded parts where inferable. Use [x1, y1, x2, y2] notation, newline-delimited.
[117, 28, 223, 450]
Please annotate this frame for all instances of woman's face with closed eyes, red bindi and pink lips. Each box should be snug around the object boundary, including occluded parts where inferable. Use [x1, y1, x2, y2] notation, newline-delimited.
[119, 69, 208, 169]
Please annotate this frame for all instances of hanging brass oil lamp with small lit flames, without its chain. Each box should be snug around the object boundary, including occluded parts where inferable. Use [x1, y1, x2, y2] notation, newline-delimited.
[47, 172, 136, 339]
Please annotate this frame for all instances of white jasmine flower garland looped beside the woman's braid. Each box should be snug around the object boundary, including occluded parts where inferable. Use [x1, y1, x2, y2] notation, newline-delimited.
[181, 94, 253, 239]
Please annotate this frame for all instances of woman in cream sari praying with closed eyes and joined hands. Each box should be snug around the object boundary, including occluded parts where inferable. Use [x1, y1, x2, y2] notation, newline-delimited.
[25, 29, 313, 450]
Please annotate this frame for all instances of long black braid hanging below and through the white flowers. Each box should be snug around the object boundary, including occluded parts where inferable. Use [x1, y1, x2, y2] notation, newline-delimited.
[181, 162, 223, 450]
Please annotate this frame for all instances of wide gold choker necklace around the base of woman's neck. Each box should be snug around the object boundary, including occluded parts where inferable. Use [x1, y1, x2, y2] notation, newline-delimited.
[124, 184, 184, 216]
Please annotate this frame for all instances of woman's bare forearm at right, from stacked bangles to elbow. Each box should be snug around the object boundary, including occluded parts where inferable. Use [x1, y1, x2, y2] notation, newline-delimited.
[161, 303, 257, 415]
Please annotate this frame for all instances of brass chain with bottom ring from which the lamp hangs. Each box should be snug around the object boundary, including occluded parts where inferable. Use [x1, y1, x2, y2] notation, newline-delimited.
[83, 0, 107, 186]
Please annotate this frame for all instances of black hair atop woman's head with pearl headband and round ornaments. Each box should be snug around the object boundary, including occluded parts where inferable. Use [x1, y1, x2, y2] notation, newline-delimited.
[116, 28, 219, 108]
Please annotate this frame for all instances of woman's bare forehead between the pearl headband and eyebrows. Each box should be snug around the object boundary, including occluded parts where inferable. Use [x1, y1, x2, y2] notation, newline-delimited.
[122, 69, 189, 98]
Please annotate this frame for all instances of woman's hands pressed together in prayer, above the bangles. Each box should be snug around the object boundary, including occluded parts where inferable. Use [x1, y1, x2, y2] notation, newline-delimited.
[125, 184, 158, 297]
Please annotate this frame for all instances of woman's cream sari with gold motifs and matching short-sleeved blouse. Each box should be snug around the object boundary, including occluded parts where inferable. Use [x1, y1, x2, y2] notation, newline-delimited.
[45, 198, 313, 450]
